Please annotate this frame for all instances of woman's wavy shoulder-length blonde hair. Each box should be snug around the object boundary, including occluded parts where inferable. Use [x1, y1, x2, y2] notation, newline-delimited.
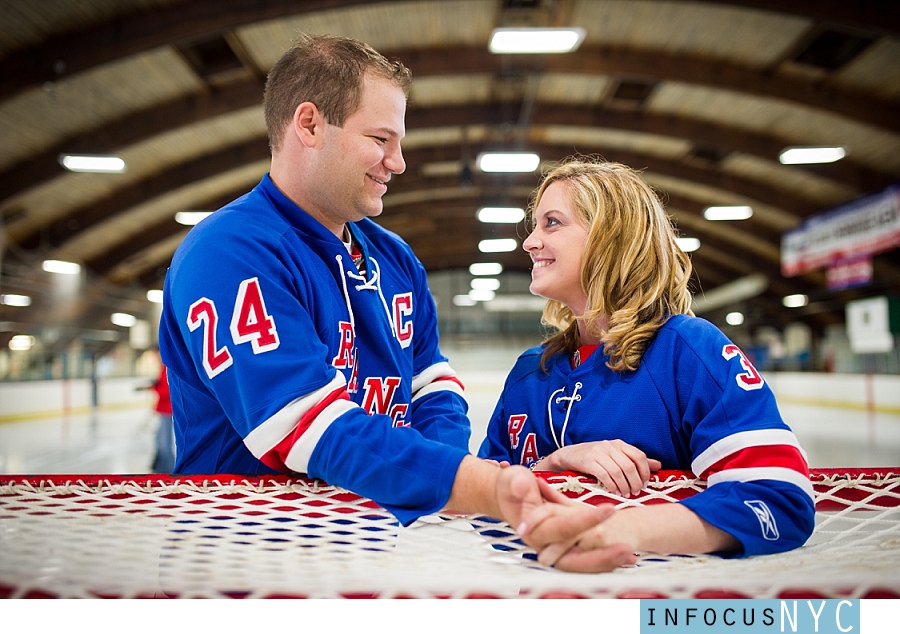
[528, 156, 693, 372]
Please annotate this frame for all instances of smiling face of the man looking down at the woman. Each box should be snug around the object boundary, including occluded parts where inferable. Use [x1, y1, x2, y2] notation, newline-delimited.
[307, 76, 406, 235]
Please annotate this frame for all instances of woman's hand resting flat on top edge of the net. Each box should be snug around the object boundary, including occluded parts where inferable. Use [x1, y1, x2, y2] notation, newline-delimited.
[535, 440, 662, 497]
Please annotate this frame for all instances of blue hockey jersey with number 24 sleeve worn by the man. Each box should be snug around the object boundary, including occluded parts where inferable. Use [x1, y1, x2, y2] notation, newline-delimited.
[159, 175, 470, 523]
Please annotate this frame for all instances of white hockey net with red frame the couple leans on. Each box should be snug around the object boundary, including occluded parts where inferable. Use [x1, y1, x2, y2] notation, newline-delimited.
[0, 468, 900, 598]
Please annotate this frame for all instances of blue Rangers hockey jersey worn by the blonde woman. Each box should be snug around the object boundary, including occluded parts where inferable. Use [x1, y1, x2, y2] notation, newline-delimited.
[479, 315, 815, 555]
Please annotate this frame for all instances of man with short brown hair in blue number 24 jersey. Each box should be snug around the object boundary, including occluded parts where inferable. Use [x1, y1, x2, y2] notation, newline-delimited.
[160, 36, 631, 567]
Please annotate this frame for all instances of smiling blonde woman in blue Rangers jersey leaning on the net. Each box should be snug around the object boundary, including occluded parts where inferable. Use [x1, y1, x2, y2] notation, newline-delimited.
[479, 157, 815, 564]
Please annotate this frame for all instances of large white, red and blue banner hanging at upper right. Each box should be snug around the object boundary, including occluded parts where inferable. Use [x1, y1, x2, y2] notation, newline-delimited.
[781, 184, 900, 277]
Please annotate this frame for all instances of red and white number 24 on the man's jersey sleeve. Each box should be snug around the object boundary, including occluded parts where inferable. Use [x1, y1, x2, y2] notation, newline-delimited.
[187, 277, 279, 378]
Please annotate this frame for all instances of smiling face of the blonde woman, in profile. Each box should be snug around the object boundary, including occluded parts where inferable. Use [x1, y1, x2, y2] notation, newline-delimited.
[522, 181, 588, 315]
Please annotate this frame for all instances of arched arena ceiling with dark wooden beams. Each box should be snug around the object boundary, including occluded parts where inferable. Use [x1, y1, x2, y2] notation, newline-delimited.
[0, 0, 900, 356]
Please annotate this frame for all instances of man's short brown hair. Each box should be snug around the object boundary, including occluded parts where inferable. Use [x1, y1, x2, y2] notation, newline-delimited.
[263, 35, 412, 152]
